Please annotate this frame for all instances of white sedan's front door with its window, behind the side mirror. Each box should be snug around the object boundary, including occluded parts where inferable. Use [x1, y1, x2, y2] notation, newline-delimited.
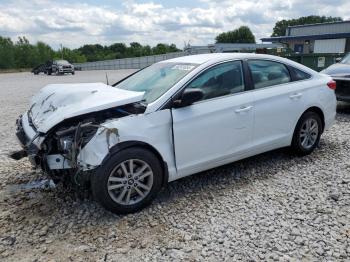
[172, 61, 254, 177]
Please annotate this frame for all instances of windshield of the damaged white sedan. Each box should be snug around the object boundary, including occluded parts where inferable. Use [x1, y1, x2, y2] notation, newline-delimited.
[115, 62, 197, 104]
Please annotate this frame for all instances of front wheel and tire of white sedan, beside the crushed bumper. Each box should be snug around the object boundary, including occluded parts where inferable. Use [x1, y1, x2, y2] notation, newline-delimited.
[91, 147, 163, 214]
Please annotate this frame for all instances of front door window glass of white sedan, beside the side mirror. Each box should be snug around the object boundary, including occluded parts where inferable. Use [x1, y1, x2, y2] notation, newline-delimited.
[186, 61, 244, 100]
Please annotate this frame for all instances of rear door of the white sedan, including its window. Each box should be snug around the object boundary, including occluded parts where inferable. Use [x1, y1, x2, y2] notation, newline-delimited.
[247, 60, 306, 149]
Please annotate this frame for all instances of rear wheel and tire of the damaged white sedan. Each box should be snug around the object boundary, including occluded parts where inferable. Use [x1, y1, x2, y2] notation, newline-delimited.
[291, 111, 322, 156]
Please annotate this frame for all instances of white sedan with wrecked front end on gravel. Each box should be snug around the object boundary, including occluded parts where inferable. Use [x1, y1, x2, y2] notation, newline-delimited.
[12, 54, 336, 213]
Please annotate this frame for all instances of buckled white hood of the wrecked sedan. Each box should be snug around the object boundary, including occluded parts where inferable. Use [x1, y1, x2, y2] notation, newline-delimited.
[29, 83, 144, 133]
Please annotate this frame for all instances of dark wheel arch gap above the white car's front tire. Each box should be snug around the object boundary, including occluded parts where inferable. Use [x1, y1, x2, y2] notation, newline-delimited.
[101, 141, 169, 187]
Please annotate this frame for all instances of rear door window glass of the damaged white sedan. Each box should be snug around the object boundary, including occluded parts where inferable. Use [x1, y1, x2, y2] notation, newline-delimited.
[248, 60, 291, 89]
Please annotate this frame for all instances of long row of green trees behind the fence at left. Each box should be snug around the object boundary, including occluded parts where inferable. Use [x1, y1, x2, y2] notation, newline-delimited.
[0, 36, 180, 69]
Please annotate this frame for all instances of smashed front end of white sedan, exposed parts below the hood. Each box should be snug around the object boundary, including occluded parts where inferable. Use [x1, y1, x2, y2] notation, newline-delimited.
[11, 103, 145, 184]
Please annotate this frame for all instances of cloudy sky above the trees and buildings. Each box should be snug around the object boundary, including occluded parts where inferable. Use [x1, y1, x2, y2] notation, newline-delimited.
[0, 0, 350, 49]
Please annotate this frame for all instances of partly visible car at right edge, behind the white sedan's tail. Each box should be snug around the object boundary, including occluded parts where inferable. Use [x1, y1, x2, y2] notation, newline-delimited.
[321, 53, 350, 103]
